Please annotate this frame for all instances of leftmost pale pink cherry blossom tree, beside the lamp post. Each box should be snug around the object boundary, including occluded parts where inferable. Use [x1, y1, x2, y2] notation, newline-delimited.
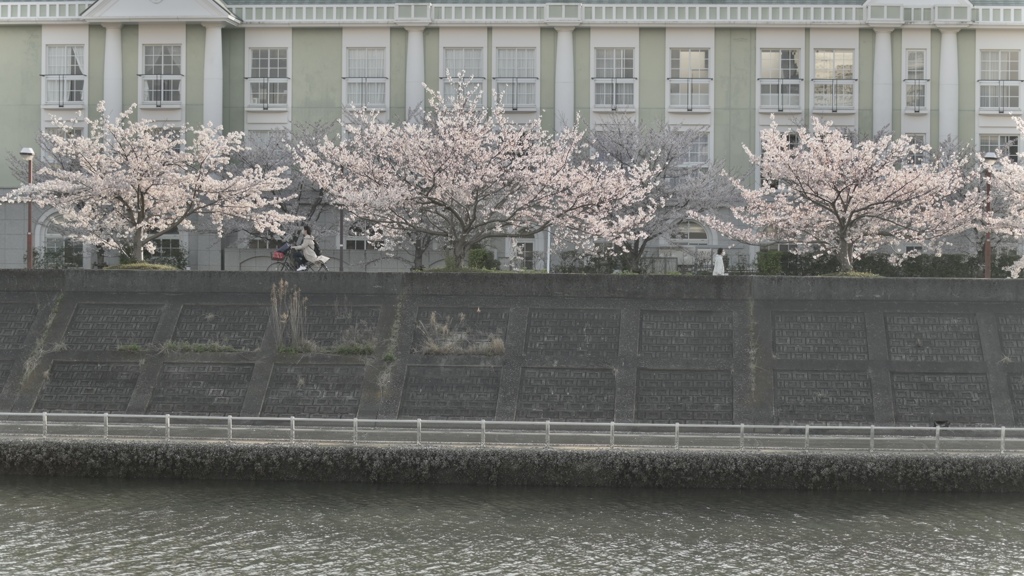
[0, 102, 300, 260]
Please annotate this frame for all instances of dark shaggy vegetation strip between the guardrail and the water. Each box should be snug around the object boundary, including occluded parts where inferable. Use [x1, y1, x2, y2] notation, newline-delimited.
[0, 440, 1024, 492]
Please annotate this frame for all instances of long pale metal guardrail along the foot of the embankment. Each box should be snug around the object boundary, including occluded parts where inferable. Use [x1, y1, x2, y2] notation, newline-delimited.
[0, 412, 1024, 454]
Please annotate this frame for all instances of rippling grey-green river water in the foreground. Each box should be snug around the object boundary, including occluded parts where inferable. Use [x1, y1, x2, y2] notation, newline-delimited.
[0, 478, 1024, 576]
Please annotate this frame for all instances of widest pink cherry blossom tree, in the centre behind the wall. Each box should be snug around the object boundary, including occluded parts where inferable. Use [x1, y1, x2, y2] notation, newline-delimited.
[295, 78, 654, 265]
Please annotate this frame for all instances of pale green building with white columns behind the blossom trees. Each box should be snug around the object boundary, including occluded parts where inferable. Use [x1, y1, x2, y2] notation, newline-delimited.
[0, 0, 1024, 270]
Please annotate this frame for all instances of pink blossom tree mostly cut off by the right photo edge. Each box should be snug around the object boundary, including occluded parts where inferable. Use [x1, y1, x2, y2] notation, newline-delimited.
[978, 117, 1024, 278]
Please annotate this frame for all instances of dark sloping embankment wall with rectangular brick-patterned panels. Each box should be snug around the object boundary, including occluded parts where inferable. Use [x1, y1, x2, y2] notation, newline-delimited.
[0, 271, 1024, 426]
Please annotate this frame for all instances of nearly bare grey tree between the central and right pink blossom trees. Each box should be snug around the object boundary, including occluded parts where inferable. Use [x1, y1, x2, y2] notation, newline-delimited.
[589, 115, 739, 273]
